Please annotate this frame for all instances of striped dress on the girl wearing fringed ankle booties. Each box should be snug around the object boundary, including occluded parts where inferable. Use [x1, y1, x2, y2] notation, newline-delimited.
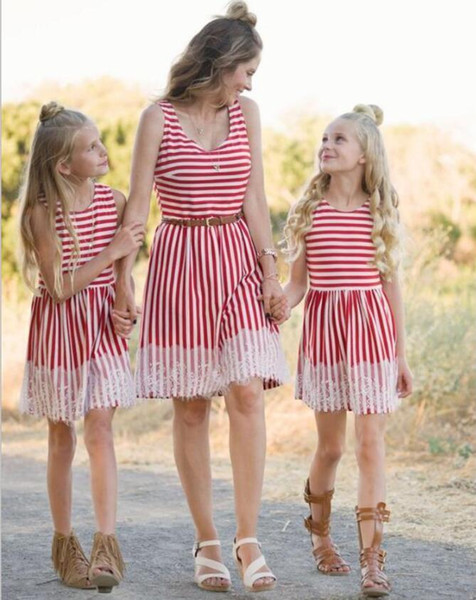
[20, 183, 135, 423]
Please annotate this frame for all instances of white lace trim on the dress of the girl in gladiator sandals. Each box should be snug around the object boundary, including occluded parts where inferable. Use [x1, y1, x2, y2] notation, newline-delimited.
[295, 359, 399, 415]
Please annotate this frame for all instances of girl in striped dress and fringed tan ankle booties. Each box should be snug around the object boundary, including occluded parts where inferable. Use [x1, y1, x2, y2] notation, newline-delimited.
[20, 102, 144, 592]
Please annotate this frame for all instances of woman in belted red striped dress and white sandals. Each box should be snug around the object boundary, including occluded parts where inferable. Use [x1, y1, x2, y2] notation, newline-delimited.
[115, 2, 286, 591]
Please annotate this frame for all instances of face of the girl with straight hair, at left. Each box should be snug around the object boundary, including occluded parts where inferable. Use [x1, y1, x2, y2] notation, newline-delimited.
[59, 123, 109, 180]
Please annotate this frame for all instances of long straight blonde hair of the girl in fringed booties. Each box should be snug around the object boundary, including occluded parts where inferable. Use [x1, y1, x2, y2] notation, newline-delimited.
[20, 102, 89, 296]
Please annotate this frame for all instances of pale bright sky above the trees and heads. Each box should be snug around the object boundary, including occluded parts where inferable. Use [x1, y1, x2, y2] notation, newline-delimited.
[2, 0, 476, 150]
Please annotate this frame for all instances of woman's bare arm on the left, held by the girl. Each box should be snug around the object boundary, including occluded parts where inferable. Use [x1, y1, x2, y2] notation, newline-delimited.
[114, 104, 164, 337]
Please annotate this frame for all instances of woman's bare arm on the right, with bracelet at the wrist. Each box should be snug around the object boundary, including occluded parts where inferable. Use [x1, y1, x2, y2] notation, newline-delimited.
[240, 98, 283, 313]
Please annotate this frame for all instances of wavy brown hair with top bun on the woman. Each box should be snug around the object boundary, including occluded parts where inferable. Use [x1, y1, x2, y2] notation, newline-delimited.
[162, 2, 263, 106]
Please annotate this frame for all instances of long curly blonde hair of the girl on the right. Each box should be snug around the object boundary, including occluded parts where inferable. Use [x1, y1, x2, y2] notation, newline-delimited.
[284, 104, 400, 279]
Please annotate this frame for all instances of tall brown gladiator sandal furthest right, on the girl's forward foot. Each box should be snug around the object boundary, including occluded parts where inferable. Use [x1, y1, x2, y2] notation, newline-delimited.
[355, 502, 391, 598]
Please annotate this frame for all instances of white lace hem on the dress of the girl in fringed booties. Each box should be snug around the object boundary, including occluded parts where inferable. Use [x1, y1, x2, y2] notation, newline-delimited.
[20, 353, 137, 423]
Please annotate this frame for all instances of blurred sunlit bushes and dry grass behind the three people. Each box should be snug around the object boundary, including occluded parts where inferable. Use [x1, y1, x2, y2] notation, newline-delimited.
[2, 78, 476, 460]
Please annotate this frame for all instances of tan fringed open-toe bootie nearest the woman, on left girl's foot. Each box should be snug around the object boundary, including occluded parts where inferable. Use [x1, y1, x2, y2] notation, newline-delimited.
[89, 531, 125, 594]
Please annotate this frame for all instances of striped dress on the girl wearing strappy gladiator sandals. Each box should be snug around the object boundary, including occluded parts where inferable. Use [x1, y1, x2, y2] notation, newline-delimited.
[296, 199, 398, 414]
